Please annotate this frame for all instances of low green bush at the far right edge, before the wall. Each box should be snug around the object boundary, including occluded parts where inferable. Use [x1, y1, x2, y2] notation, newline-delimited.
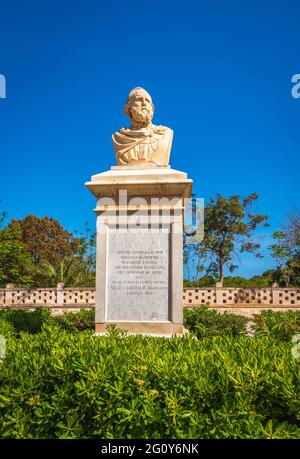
[253, 310, 300, 341]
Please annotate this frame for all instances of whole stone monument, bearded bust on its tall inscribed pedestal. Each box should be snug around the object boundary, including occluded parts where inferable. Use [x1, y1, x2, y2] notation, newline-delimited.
[86, 87, 192, 337]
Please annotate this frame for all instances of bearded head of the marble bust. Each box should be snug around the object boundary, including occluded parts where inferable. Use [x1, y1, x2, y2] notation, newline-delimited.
[124, 87, 154, 127]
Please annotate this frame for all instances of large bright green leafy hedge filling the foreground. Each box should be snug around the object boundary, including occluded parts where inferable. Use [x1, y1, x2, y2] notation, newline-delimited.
[0, 321, 300, 439]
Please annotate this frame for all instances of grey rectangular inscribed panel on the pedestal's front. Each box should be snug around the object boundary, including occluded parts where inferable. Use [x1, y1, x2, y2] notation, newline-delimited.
[106, 230, 170, 322]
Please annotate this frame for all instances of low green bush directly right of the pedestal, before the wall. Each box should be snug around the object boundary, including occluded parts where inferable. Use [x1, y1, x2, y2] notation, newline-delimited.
[184, 306, 249, 338]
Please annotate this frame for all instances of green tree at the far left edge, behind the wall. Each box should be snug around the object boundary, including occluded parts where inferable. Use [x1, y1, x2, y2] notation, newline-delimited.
[0, 224, 34, 287]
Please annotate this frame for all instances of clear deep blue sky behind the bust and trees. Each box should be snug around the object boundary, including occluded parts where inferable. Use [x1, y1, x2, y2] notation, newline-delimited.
[0, 0, 300, 276]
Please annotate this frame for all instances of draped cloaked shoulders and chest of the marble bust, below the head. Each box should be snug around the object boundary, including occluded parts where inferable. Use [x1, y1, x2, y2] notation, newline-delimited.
[112, 124, 173, 166]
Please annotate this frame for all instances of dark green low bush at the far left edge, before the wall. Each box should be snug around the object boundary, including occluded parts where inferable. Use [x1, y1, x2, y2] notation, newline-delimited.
[0, 307, 52, 333]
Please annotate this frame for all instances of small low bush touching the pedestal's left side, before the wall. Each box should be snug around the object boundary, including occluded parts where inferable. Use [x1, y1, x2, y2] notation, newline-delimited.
[54, 309, 95, 332]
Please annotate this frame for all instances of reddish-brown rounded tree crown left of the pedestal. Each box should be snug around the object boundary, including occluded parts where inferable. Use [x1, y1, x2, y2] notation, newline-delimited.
[9, 215, 80, 265]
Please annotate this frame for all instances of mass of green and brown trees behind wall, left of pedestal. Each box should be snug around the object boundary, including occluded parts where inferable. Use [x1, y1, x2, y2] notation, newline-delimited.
[0, 213, 95, 287]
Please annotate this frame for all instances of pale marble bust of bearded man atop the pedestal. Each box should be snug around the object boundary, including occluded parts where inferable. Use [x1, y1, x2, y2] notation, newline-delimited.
[112, 87, 173, 167]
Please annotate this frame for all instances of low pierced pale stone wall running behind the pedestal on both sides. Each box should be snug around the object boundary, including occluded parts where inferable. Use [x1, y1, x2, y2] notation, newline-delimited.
[0, 284, 300, 315]
